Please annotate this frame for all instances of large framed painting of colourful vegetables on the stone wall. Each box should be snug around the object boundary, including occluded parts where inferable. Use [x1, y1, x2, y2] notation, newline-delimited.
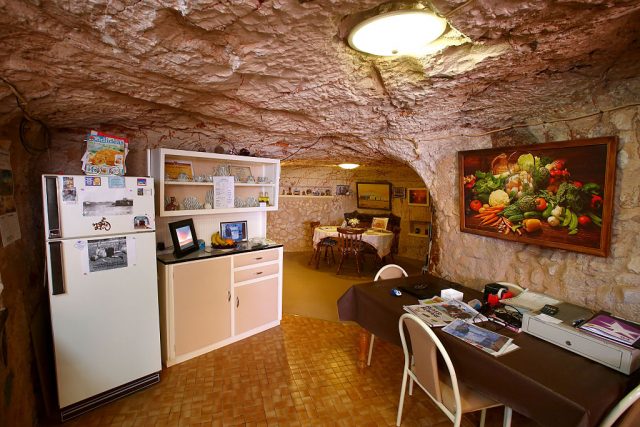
[458, 137, 618, 257]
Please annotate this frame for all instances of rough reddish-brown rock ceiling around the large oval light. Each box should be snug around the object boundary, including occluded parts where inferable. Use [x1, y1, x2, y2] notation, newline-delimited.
[0, 0, 640, 166]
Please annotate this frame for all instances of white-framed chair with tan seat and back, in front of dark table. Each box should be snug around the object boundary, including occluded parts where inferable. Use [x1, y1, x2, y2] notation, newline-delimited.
[396, 314, 512, 427]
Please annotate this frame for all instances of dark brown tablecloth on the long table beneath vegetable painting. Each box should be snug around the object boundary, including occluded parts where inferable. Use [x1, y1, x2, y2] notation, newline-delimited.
[338, 275, 640, 427]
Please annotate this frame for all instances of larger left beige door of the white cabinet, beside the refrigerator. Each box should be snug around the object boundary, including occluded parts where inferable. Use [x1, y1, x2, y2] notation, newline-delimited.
[173, 257, 231, 357]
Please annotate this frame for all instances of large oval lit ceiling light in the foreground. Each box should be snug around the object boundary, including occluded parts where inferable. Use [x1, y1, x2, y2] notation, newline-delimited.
[348, 9, 447, 56]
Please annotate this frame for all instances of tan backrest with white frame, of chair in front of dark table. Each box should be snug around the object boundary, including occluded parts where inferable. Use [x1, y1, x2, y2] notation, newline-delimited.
[398, 313, 462, 425]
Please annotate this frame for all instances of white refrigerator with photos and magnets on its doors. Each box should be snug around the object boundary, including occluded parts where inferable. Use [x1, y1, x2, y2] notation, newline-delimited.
[42, 175, 161, 421]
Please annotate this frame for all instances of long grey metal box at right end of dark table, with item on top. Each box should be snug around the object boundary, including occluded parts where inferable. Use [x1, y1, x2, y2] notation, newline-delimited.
[522, 303, 640, 375]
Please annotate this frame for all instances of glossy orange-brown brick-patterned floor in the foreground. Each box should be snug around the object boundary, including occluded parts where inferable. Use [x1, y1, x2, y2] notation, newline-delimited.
[61, 315, 531, 426]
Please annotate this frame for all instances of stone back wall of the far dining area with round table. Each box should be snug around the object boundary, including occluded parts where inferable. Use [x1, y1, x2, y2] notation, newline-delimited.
[267, 163, 430, 260]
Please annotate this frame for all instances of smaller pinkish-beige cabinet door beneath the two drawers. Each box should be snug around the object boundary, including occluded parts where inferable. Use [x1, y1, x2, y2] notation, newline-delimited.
[234, 277, 278, 335]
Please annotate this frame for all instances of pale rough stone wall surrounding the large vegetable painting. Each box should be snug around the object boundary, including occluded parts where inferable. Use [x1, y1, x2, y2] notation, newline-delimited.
[414, 106, 640, 321]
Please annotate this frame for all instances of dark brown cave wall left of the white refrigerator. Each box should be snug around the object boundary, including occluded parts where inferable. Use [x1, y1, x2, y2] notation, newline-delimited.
[0, 118, 47, 427]
